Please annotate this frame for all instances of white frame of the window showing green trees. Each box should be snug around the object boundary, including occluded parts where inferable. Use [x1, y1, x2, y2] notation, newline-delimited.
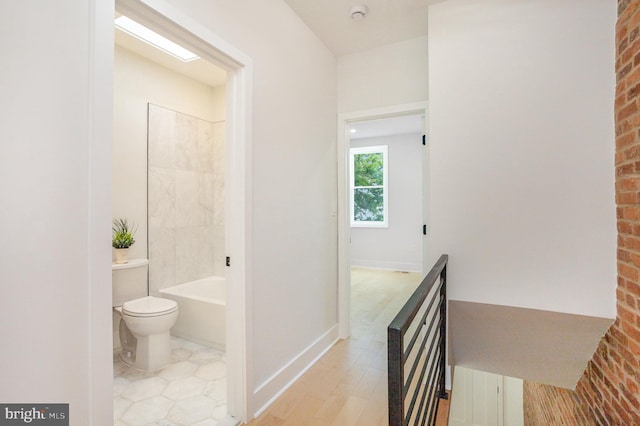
[349, 145, 389, 228]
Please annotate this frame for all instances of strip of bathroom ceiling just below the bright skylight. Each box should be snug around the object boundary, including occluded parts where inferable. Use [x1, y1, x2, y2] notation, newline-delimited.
[115, 25, 227, 87]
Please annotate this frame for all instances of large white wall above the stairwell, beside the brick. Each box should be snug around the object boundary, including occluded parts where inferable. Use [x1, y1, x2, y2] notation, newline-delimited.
[429, 0, 616, 317]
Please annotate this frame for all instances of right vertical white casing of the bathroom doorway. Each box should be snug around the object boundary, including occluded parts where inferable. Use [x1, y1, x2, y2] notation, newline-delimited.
[225, 65, 254, 422]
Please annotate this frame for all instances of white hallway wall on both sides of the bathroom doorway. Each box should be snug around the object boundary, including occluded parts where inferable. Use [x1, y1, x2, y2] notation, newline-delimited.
[0, 0, 337, 426]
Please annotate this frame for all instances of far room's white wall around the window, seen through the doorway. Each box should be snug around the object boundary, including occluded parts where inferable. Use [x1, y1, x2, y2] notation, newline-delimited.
[350, 133, 425, 272]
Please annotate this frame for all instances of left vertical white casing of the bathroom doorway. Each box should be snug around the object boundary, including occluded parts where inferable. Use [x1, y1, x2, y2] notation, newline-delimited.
[89, 0, 114, 426]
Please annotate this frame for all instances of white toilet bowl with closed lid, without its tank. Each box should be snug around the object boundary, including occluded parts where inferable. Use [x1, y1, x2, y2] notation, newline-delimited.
[114, 296, 178, 371]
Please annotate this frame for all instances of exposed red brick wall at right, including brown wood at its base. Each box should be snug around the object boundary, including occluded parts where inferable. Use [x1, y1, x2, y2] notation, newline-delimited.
[524, 0, 640, 426]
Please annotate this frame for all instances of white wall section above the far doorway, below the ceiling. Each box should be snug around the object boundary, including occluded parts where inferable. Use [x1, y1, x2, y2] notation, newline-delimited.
[338, 36, 429, 113]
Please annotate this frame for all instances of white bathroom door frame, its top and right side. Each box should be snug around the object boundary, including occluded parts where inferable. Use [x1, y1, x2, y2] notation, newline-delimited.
[116, 0, 253, 422]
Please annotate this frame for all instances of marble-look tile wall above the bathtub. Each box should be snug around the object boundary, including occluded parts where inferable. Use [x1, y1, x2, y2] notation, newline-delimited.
[148, 104, 225, 294]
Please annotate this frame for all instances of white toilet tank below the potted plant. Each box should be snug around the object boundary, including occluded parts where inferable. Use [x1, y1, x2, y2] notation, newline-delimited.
[111, 259, 149, 306]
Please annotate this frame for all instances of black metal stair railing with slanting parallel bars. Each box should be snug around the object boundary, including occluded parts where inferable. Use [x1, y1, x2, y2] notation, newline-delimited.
[387, 255, 448, 426]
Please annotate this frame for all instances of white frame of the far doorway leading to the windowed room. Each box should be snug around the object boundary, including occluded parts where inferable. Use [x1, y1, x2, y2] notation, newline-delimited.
[336, 102, 428, 339]
